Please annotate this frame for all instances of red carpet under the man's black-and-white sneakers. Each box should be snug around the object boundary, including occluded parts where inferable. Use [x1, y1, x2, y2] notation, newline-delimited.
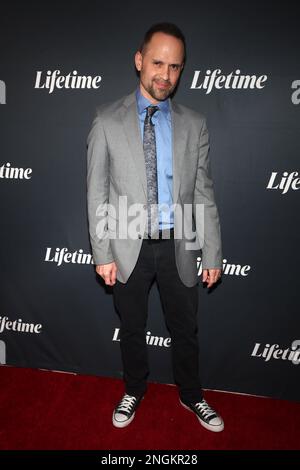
[0, 366, 300, 450]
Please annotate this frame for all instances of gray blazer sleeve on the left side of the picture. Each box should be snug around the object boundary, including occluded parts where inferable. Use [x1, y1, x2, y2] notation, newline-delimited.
[87, 111, 114, 265]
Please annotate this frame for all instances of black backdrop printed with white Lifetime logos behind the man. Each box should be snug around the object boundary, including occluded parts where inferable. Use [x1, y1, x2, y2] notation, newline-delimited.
[0, 0, 300, 400]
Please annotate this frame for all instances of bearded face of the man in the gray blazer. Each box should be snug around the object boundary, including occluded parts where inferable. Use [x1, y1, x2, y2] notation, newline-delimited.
[135, 33, 184, 104]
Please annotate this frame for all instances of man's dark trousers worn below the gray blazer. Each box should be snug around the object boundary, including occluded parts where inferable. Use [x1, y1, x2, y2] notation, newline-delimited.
[113, 233, 202, 401]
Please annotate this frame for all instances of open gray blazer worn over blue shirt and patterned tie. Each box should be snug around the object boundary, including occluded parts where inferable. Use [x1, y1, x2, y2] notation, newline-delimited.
[87, 91, 222, 287]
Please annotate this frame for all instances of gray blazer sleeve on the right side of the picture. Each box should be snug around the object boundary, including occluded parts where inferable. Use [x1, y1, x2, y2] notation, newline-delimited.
[194, 117, 223, 269]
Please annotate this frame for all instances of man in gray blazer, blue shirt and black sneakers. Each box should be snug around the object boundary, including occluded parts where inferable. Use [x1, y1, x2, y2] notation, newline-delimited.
[87, 23, 224, 432]
